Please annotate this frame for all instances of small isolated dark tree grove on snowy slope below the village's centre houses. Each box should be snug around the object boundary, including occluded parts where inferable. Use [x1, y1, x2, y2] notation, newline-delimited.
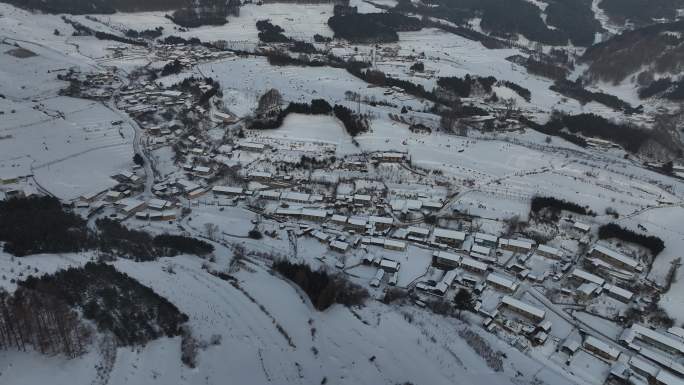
[273, 260, 368, 311]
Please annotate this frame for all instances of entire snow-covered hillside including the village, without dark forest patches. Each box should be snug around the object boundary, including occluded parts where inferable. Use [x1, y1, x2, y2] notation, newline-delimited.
[0, 0, 684, 385]
